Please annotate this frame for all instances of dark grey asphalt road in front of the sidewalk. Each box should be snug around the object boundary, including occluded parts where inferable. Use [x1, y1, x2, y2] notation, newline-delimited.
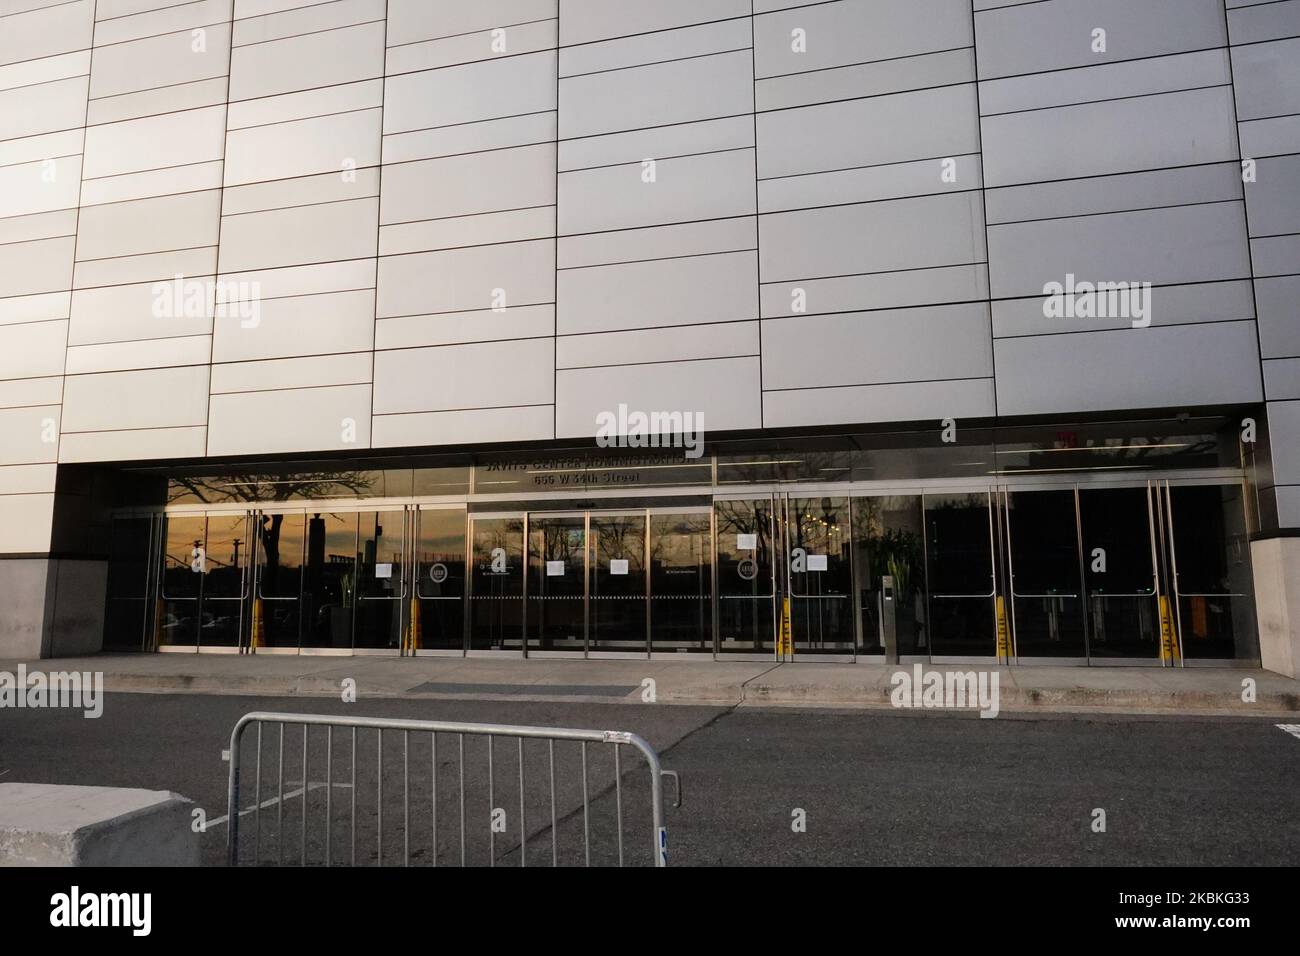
[0, 695, 1300, 866]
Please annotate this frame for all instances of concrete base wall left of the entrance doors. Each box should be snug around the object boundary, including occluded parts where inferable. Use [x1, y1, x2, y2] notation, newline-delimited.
[0, 558, 108, 659]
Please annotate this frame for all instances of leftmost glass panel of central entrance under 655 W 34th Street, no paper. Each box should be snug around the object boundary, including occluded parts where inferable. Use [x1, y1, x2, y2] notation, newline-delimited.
[467, 515, 524, 653]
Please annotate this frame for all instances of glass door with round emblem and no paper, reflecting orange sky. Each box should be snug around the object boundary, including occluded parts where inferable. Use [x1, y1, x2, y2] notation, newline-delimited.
[413, 509, 465, 652]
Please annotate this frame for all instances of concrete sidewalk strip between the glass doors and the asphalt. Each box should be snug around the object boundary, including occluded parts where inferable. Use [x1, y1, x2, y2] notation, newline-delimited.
[0, 654, 1300, 717]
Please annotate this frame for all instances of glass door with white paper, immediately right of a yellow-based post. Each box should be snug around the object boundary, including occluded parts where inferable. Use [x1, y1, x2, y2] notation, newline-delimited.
[784, 497, 854, 657]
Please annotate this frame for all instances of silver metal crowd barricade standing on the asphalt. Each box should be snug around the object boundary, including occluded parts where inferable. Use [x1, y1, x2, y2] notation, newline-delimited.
[226, 711, 681, 866]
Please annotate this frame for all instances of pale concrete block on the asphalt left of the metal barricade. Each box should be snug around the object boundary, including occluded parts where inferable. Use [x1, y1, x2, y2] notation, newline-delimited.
[0, 783, 199, 866]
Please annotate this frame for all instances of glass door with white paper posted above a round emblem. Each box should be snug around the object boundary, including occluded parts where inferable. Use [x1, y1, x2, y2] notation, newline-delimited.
[714, 497, 776, 654]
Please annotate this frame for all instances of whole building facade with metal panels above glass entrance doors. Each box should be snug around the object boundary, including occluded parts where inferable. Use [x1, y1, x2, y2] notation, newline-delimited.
[0, 0, 1300, 674]
